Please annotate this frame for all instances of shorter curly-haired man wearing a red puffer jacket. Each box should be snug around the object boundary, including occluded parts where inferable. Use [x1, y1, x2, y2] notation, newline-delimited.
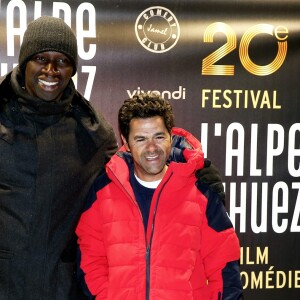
[76, 94, 242, 300]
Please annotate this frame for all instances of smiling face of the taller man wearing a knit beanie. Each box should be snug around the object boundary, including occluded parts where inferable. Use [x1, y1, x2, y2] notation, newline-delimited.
[25, 51, 73, 101]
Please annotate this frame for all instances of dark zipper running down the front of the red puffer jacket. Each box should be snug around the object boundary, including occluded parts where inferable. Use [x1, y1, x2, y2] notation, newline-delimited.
[145, 172, 173, 300]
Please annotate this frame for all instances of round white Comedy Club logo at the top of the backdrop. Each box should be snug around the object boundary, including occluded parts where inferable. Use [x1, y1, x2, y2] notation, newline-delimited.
[135, 6, 180, 53]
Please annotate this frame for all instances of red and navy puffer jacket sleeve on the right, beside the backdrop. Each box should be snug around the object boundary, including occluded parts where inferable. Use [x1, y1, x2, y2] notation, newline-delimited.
[198, 179, 242, 300]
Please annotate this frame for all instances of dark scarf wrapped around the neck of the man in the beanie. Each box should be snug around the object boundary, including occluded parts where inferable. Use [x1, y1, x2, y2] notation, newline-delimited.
[11, 67, 75, 116]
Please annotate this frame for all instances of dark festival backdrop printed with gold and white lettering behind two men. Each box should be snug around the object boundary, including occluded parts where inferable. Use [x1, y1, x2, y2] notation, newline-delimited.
[0, 0, 300, 300]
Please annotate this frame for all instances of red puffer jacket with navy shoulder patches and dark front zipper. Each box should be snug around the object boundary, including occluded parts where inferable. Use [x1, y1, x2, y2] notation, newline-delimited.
[77, 129, 241, 300]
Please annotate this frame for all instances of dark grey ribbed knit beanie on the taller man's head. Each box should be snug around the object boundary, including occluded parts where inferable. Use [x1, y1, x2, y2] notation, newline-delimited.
[19, 16, 78, 75]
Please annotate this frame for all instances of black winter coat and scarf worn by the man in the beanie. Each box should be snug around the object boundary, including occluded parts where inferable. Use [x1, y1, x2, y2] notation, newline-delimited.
[0, 68, 117, 300]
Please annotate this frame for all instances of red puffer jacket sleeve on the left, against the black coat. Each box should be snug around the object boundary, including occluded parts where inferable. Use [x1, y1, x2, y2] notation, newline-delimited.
[76, 195, 108, 300]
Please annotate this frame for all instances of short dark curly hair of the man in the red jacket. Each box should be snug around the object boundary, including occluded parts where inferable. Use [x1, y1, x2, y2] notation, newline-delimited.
[118, 93, 174, 141]
